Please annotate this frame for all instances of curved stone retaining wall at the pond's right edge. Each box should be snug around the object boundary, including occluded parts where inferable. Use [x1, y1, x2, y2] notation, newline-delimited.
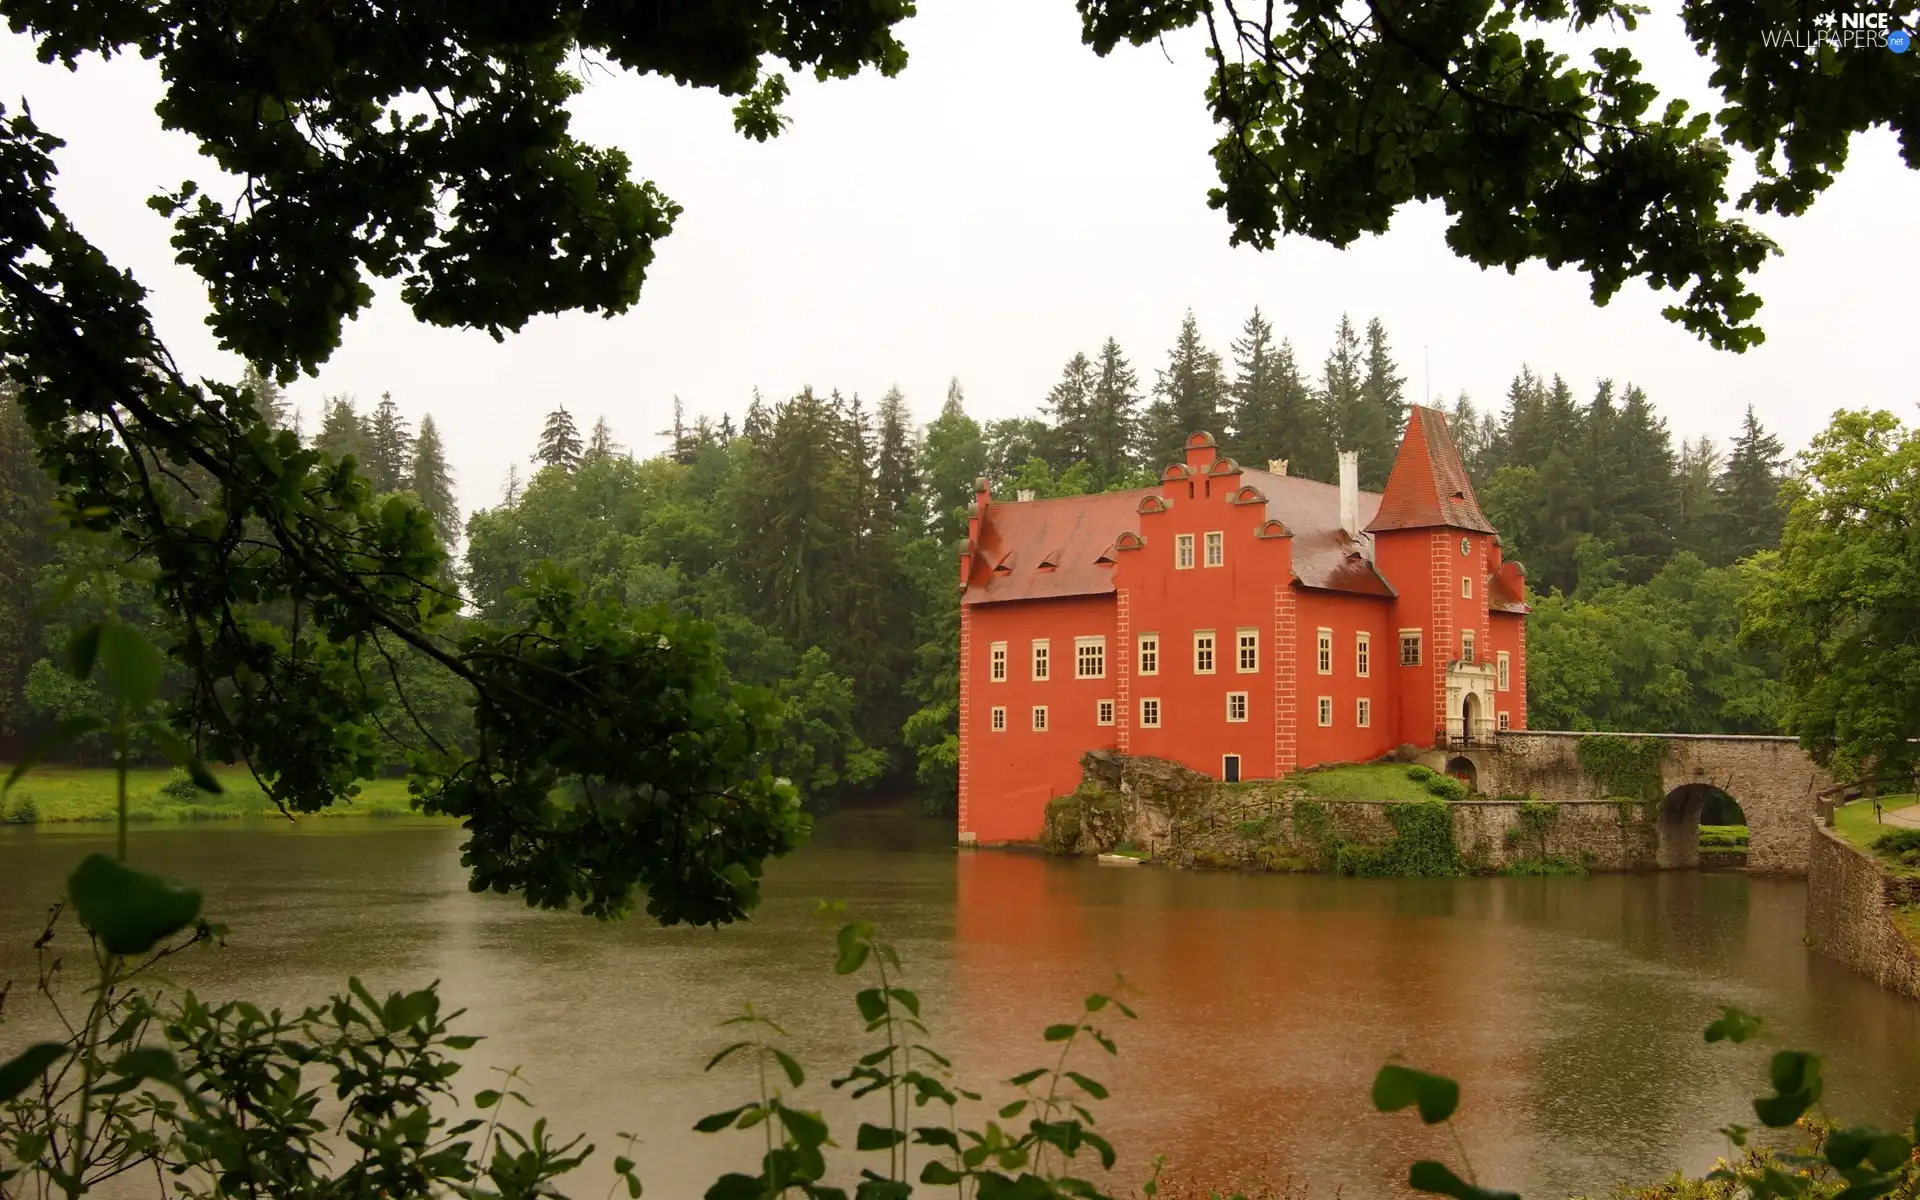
[1807, 824, 1920, 1000]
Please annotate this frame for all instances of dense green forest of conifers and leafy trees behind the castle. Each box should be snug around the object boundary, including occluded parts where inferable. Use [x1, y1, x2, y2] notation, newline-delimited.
[0, 309, 1786, 810]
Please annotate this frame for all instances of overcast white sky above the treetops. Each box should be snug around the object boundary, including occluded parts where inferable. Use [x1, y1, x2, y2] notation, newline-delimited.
[0, 0, 1920, 509]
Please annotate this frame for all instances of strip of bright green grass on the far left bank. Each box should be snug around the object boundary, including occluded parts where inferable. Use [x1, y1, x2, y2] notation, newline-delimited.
[0, 766, 428, 826]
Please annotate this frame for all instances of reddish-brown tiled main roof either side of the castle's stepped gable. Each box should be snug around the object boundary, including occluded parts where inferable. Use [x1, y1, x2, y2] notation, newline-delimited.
[964, 468, 1394, 605]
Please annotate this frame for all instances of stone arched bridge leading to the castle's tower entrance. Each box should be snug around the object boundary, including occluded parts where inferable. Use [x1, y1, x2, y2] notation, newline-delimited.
[1436, 730, 1834, 876]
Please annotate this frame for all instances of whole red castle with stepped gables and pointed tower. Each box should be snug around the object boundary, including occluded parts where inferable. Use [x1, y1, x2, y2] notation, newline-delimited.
[960, 409, 1526, 843]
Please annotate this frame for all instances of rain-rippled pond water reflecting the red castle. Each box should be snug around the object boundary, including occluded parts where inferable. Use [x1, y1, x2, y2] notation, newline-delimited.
[0, 814, 1920, 1196]
